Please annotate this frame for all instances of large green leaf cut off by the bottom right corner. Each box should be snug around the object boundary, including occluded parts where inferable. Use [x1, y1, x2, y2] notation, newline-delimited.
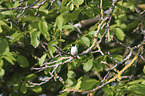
[128, 84, 145, 96]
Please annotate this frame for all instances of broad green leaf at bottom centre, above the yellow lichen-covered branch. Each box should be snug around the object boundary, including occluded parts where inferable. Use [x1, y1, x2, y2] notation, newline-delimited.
[81, 77, 99, 90]
